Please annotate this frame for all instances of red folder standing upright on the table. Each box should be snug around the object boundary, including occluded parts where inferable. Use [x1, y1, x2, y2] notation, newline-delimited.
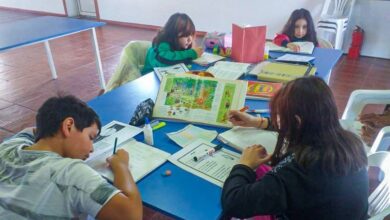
[231, 24, 266, 63]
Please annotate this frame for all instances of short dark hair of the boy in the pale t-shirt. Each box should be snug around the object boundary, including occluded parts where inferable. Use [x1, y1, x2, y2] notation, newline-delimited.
[35, 95, 101, 141]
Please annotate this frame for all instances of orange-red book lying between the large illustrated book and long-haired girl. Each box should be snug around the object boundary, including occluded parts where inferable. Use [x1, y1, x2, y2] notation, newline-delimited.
[246, 81, 283, 100]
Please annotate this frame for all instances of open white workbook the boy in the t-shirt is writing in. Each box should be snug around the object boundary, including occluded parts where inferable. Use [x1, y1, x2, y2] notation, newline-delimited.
[85, 121, 170, 181]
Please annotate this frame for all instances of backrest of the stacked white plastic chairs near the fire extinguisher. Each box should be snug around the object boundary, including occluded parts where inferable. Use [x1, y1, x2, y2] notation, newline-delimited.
[321, 0, 355, 18]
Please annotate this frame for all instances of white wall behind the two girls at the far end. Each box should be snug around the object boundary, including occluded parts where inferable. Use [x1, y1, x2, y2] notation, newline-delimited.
[98, 0, 324, 39]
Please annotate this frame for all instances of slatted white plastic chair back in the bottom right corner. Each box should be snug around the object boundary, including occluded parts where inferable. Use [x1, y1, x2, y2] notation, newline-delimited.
[368, 151, 390, 216]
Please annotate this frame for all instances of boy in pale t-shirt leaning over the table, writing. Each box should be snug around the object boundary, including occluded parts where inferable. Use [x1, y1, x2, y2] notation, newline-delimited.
[0, 96, 142, 219]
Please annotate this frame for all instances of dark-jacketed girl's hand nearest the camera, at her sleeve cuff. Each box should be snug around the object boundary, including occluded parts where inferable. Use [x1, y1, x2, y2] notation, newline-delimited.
[238, 145, 272, 169]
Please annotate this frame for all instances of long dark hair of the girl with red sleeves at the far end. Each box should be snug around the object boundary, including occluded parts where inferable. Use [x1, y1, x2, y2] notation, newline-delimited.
[282, 8, 318, 46]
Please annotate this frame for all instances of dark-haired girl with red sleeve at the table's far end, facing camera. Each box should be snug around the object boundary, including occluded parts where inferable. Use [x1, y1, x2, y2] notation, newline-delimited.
[273, 8, 318, 52]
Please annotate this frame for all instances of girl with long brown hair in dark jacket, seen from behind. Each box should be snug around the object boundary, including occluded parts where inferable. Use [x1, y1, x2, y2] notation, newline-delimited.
[221, 77, 368, 219]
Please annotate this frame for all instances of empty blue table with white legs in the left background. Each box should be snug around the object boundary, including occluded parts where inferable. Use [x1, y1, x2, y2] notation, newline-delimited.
[0, 16, 106, 89]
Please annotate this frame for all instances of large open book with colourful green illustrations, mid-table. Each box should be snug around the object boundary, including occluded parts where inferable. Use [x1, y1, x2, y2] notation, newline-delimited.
[153, 74, 247, 127]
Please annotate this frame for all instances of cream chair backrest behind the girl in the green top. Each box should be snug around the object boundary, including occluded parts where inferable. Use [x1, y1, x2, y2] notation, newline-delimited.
[105, 41, 152, 92]
